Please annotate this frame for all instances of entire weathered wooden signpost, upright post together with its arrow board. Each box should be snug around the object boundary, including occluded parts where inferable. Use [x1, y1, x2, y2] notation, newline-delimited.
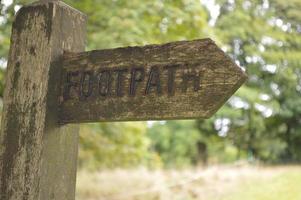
[0, 0, 246, 200]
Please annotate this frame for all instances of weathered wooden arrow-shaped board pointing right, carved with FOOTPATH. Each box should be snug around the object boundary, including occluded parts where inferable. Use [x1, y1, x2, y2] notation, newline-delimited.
[60, 39, 246, 123]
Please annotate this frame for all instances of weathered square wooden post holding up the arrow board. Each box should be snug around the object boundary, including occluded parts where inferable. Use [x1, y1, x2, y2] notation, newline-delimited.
[0, 1, 86, 200]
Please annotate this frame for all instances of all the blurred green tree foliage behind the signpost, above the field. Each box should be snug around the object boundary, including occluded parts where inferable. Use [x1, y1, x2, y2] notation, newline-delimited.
[0, 0, 301, 169]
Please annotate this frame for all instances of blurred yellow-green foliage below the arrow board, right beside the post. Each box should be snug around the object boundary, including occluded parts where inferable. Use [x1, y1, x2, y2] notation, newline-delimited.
[79, 122, 162, 170]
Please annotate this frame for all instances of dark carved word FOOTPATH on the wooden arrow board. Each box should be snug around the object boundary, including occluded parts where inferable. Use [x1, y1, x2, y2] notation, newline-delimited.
[64, 65, 201, 100]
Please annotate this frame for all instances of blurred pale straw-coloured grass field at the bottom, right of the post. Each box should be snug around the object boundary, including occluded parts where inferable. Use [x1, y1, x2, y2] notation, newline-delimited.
[77, 166, 301, 200]
